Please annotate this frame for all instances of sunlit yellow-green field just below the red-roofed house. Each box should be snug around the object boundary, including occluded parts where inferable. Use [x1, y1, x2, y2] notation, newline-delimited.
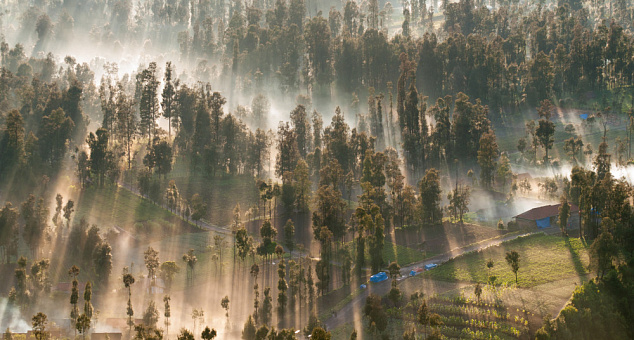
[427, 234, 589, 287]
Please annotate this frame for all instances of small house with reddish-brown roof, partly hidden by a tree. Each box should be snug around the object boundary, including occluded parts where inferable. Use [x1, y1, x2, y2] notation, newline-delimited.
[515, 203, 580, 229]
